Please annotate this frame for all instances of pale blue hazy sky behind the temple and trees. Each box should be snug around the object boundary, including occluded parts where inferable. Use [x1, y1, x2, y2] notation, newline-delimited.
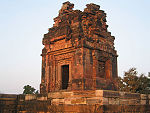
[0, 0, 150, 93]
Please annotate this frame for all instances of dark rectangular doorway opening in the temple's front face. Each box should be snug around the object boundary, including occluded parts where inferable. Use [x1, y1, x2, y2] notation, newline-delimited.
[61, 65, 69, 89]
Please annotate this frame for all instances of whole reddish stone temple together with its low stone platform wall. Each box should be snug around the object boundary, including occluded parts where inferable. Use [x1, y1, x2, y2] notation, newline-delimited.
[0, 2, 150, 113]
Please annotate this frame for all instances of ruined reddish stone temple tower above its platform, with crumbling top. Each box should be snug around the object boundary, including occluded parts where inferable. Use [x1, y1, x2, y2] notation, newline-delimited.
[40, 2, 118, 93]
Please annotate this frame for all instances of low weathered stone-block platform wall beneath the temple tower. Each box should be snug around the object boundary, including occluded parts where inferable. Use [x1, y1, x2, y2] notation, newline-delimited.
[0, 90, 150, 113]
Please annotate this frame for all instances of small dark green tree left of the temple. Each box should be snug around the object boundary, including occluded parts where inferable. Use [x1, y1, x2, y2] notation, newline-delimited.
[23, 85, 38, 94]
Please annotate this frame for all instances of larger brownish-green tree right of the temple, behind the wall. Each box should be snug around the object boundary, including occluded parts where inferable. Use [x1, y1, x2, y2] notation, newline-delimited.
[118, 68, 150, 94]
